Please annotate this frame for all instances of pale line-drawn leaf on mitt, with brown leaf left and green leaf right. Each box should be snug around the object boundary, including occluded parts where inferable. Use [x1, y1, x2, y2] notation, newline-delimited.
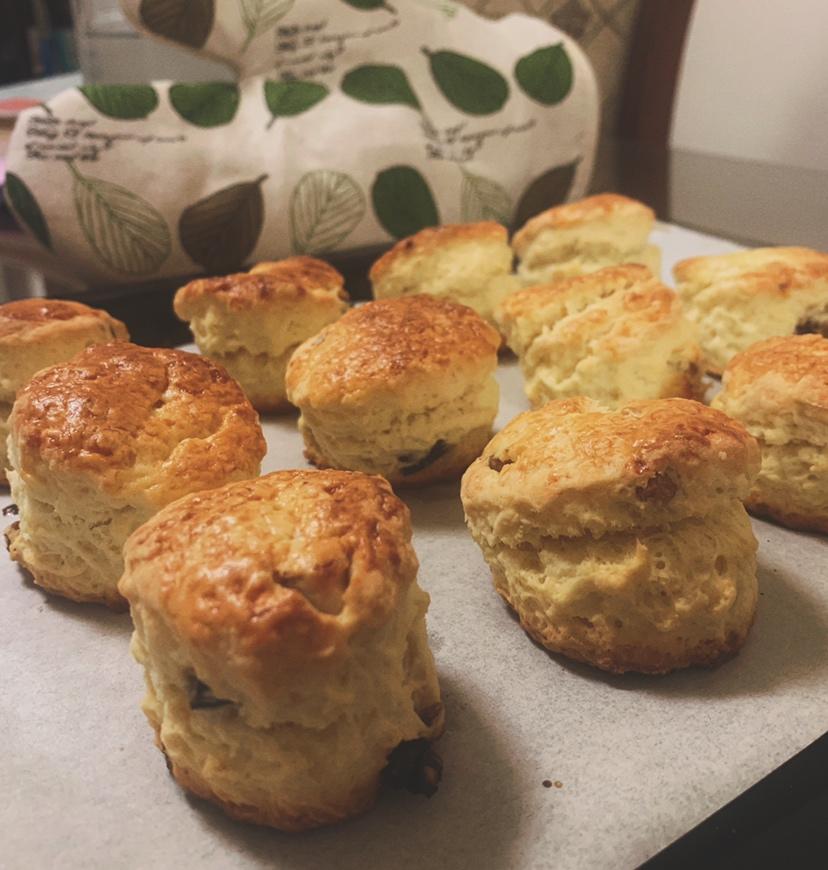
[290, 169, 365, 254]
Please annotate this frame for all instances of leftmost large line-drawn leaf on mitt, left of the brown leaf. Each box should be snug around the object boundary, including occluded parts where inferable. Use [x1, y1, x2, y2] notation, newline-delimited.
[72, 163, 171, 275]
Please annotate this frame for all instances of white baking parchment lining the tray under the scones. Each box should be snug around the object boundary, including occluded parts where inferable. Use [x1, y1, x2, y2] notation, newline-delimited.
[0, 226, 828, 870]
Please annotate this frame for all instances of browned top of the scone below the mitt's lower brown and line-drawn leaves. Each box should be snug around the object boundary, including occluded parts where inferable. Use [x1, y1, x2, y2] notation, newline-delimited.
[174, 257, 348, 319]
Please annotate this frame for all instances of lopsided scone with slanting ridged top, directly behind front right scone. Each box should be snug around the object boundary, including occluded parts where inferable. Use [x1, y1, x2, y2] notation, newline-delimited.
[498, 264, 703, 407]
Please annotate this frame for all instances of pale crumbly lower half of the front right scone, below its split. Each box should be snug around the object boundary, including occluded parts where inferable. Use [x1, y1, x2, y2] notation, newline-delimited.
[472, 501, 758, 673]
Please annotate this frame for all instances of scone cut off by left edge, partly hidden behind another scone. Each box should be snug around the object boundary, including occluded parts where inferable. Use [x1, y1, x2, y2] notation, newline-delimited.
[0, 299, 129, 482]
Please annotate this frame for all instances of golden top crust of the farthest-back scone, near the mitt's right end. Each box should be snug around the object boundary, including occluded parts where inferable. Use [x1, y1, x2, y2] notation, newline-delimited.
[512, 193, 655, 257]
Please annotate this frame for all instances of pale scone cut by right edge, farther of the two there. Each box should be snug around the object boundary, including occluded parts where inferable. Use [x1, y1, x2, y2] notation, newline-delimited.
[673, 248, 828, 374]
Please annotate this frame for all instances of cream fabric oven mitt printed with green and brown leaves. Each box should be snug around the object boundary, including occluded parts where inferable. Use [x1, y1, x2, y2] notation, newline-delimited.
[6, 0, 598, 286]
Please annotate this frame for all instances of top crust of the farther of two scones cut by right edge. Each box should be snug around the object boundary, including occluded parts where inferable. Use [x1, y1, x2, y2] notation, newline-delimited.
[673, 247, 828, 298]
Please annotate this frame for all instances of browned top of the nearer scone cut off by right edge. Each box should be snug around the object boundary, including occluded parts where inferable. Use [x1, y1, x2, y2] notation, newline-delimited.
[715, 335, 828, 445]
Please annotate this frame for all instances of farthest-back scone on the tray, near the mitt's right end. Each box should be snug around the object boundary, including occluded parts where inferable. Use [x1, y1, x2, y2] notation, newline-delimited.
[512, 193, 661, 285]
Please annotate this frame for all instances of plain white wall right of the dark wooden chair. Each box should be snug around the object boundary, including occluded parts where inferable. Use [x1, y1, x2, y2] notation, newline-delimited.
[665, 0, 828, 170]
